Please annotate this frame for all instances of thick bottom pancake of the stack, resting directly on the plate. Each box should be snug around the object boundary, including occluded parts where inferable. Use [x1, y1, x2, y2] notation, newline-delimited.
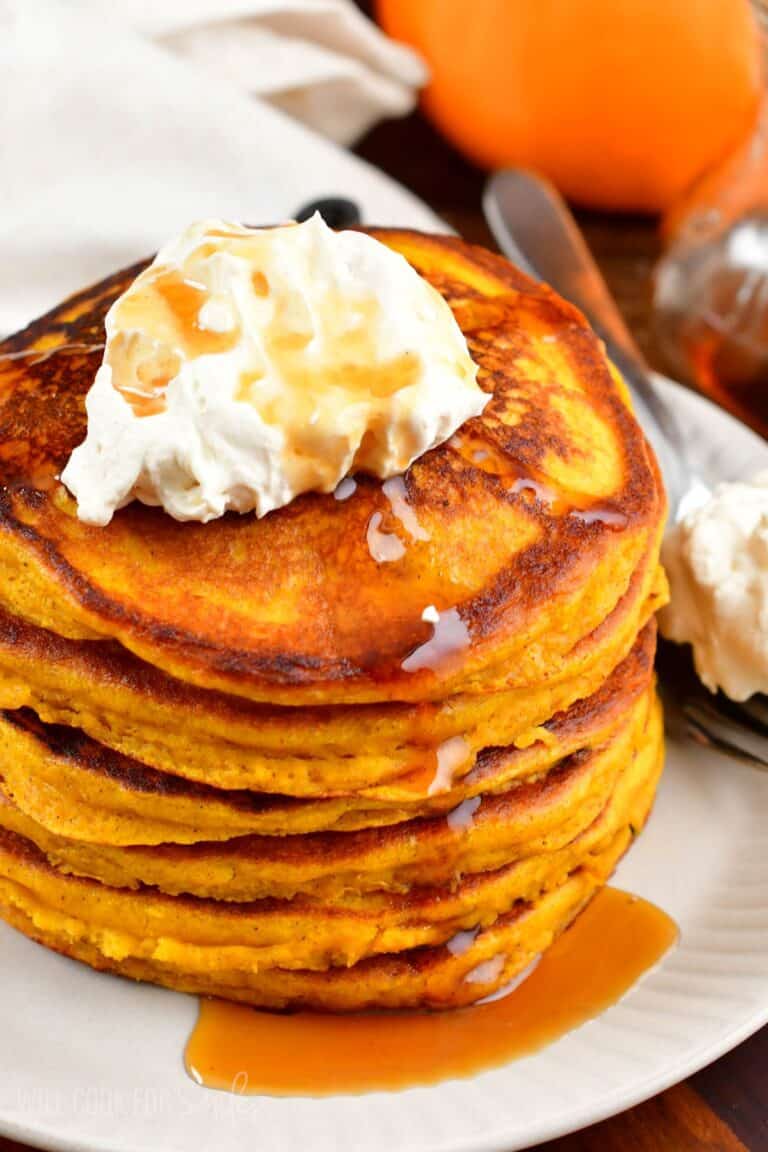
[0, 711, 661, 1011]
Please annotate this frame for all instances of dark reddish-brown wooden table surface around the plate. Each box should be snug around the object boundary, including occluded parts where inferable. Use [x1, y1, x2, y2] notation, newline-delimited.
[0, 92, 768, 1152]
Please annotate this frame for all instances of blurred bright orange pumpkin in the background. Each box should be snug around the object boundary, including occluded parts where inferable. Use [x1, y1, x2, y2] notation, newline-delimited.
[377, 0, 762, 212]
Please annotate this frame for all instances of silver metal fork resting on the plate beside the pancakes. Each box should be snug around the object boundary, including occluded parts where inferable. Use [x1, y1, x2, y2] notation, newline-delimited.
[482, 169, 768, 768]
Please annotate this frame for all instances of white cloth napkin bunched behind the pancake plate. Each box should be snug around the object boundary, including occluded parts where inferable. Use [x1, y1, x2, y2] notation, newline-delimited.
[0, 0, 436, 333]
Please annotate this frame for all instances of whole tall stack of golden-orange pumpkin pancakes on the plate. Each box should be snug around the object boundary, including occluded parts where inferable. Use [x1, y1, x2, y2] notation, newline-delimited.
[0, 232, 666, 1010]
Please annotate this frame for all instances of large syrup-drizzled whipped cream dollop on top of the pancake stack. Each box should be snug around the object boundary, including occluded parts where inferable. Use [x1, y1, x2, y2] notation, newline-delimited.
[61, 215, 488, 525]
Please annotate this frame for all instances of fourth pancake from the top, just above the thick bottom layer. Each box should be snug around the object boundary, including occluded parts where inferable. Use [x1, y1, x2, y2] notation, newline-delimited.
[0, 689, 657, 902]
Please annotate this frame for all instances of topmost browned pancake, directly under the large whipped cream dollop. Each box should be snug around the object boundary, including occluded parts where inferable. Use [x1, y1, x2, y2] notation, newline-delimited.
[0, 230, 664, 704]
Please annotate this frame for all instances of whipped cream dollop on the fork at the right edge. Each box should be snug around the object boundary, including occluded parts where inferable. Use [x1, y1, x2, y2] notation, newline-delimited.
[660, 471, 768, 700]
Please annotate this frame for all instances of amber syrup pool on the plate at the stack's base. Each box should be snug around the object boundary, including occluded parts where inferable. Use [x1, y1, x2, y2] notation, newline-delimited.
[184, 888, 677, 1096]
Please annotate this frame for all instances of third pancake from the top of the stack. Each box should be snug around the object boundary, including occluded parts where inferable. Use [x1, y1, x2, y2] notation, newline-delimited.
[0, 621, 655, 846]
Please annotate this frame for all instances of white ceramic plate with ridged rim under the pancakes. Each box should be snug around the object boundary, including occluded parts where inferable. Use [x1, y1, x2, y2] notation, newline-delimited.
[0, 375, 768, 1152]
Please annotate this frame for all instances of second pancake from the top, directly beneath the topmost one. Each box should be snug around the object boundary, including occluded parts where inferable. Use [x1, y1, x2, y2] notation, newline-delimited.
[0, 555, 667, 803]
